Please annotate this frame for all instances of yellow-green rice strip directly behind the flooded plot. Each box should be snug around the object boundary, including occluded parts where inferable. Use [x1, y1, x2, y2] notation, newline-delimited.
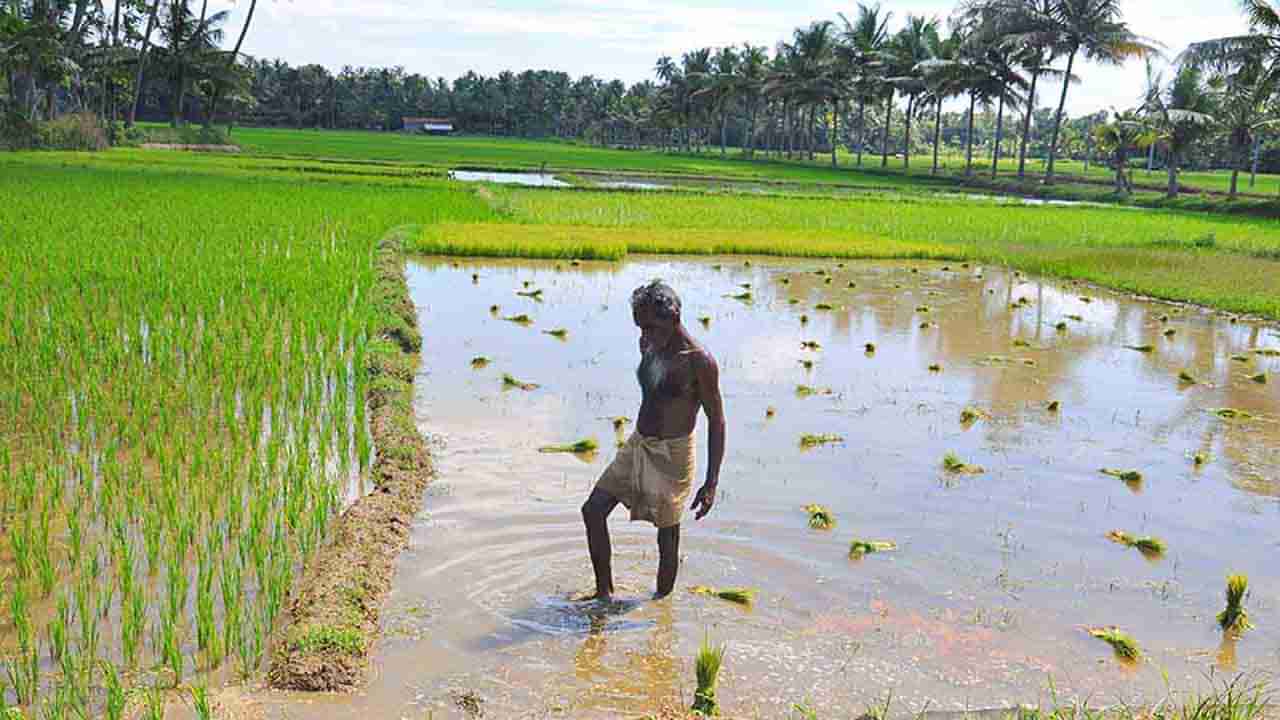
[419, 181, 1280, 318]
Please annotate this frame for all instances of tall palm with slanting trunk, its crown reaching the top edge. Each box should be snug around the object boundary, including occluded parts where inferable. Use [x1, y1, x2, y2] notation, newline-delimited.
[1002, 0, 1162, 184]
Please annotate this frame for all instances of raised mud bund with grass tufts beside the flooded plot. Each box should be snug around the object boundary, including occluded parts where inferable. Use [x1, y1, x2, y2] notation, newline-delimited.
[268, 228, 433, 691]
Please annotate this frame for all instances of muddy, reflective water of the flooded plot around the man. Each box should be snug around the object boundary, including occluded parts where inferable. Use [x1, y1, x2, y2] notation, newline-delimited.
[285, 258, 1280, 717]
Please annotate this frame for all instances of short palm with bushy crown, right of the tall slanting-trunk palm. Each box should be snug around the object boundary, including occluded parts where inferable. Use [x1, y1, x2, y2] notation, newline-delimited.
[1143, 60, 1215, 197]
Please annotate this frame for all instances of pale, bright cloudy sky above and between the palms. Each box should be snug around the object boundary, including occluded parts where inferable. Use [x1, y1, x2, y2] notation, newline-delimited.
[210, 0, 1247, 115]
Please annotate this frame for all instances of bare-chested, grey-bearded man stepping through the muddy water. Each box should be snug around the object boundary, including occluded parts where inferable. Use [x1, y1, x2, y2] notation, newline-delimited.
[582, 281, 724, 601]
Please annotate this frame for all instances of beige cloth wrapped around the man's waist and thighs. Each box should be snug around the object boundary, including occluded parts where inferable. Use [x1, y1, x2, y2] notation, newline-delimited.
[595, 433, 696, 528]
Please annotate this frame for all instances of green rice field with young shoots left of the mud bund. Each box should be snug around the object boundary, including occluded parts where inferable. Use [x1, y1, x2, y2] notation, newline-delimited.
[0, 155, 489, 717]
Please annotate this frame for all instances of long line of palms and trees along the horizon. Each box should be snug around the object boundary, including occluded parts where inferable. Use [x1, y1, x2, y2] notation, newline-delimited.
[0, 0, 1280, 195]
